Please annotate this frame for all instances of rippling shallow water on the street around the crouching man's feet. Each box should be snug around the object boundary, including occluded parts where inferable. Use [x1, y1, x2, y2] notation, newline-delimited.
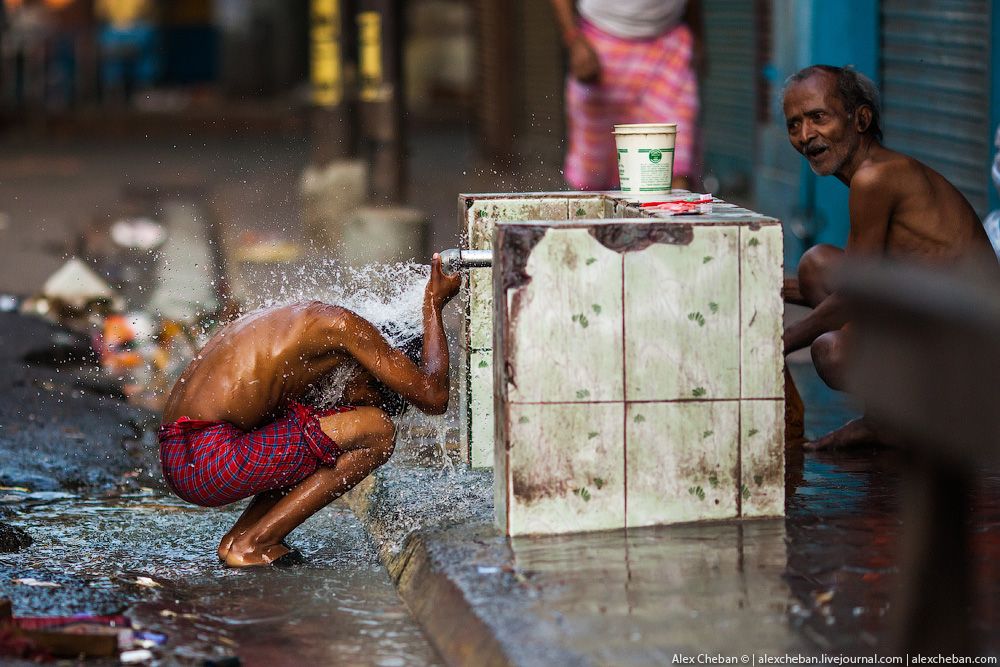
[0, 494, 439, 667]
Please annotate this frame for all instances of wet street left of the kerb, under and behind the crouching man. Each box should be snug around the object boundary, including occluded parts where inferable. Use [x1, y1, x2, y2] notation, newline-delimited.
[0, 314, 439, 667]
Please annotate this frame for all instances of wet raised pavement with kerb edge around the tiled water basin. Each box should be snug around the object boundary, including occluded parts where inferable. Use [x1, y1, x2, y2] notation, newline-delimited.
[352, 364, 1000, 665]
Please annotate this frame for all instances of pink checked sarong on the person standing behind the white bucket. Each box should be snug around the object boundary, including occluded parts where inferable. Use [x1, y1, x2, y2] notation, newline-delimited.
[565, 21, 699, 190]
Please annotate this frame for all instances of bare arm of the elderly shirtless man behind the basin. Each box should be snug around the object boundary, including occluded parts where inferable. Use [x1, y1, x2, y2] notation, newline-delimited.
[782, 168, 893, 355]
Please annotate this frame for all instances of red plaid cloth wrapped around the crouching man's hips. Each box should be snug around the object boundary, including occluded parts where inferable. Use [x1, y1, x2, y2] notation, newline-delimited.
[158, 402, 354, 507]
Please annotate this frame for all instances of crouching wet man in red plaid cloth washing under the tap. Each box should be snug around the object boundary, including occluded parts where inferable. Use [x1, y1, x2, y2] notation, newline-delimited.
[159, 254, 461, 567]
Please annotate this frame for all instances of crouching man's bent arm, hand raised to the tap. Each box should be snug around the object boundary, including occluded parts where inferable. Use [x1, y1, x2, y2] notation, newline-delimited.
[323, 254, 462, 414]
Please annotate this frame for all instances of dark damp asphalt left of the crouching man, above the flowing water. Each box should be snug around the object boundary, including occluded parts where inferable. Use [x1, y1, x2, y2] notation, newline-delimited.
[0, 313, 160, 495]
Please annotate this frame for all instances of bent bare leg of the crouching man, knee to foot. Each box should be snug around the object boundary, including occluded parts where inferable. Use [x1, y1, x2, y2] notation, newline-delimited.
[226, 407, 396, 567]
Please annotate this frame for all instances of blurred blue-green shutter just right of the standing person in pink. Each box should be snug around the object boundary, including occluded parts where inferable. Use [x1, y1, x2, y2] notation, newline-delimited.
[701, 0, 757, 196]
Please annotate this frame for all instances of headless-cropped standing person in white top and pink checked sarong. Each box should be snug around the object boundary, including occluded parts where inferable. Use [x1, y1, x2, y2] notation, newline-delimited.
[551, 0, 703, 190]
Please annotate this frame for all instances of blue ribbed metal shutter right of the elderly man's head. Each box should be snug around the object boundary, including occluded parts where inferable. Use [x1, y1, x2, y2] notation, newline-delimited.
[881, 0, 992, 216]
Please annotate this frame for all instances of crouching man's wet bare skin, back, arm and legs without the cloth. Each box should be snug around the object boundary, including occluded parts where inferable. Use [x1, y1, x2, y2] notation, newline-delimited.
[163, 254, 461, 567]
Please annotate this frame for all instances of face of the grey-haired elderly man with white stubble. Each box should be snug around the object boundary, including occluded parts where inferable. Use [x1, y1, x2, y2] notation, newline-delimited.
[784, 72, 861, 176]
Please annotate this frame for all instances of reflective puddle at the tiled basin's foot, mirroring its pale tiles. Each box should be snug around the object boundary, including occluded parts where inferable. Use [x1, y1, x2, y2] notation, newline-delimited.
[500, 367, 1000, 665]
